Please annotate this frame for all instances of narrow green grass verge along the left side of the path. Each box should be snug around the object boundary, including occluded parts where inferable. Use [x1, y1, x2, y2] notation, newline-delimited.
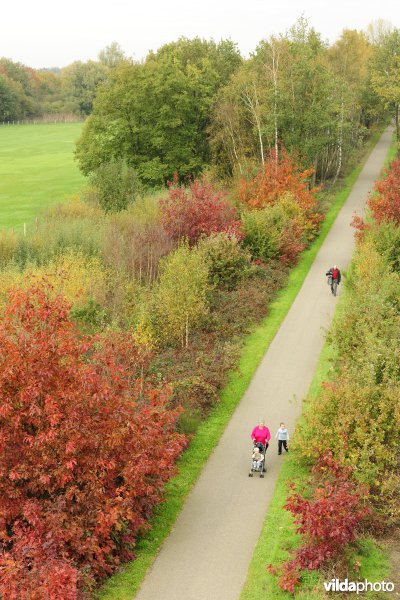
[97, 132, 388, 600]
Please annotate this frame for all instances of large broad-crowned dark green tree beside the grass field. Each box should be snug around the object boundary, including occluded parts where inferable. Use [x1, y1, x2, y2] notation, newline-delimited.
[77, 38, 241, 184]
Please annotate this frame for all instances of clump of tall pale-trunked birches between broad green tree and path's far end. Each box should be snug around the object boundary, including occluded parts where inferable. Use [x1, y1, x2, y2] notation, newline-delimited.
[210, 18, 381, 180]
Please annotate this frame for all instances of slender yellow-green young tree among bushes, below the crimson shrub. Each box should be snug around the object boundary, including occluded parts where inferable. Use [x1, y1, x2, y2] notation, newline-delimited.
[155, 244, 209, 347]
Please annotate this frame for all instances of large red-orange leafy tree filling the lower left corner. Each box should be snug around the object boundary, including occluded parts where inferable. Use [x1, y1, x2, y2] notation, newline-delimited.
[0, 285, 185, 600]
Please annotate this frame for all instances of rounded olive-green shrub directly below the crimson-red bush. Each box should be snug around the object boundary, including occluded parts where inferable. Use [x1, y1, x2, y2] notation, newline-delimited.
[199, 233, 251, 287]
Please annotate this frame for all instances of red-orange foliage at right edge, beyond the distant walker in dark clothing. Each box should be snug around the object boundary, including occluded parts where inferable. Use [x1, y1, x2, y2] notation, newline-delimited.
[368, 158, 400, 225]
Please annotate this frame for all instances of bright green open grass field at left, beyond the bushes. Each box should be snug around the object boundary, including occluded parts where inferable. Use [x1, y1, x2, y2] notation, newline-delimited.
[0, 123, 85, 228]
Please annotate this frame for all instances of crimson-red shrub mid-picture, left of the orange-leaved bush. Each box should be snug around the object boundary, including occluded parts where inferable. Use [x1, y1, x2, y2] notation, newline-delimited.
[160, 180, 243, 245]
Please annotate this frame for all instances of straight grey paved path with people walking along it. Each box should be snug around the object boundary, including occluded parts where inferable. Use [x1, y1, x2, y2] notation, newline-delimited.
[136, 128, 392, 600]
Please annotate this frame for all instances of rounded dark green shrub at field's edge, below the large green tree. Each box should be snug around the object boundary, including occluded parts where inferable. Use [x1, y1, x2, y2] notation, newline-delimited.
[90, 159, 143, 212]
